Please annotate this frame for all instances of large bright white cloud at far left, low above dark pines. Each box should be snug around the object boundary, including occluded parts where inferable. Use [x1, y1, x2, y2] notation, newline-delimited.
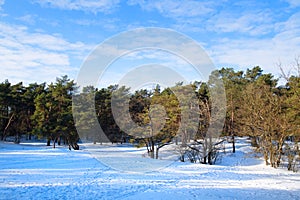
[0, 23, 90, 83]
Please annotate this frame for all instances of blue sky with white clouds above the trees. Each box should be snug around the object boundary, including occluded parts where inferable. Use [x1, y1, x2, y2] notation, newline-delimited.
[0, 0, 300, 86]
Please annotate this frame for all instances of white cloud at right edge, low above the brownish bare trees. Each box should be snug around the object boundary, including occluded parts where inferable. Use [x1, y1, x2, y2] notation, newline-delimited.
[210, 13, 300, 79]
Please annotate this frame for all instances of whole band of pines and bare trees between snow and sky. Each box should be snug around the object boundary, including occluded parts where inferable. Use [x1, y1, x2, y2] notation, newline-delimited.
[0, 66, 300, 170]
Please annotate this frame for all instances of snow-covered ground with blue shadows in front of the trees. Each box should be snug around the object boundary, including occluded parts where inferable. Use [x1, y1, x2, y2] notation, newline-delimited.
[0, 138, 300, 200]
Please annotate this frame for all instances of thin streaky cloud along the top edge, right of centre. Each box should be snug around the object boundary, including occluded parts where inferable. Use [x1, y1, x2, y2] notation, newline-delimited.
[128, 0, 274, 36]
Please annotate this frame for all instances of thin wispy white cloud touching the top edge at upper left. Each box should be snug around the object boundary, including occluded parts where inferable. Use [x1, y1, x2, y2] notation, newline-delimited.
[35, 0, 119, 13]
